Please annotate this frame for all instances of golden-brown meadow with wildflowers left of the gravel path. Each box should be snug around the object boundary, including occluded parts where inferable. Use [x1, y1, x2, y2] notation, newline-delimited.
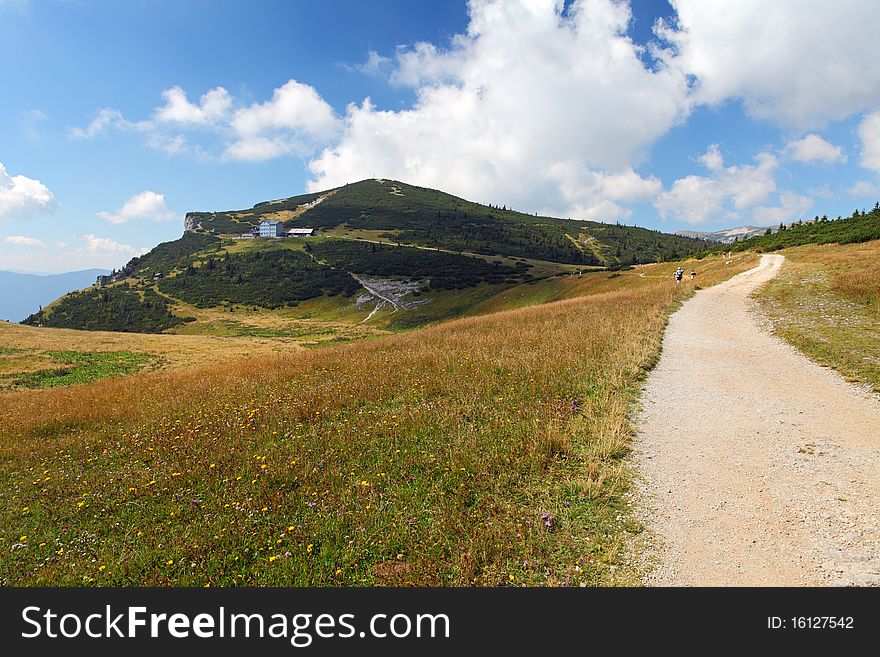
[0, 256, 754, 585]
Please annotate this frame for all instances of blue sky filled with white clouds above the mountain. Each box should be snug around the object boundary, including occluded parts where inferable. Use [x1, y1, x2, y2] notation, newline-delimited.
[0, 0, 880, 272]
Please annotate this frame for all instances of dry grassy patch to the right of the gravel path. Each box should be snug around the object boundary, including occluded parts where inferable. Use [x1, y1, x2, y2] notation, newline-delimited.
[757, 240, 880, 392]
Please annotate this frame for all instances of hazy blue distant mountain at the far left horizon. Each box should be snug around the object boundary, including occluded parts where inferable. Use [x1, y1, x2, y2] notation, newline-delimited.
[0, 269, 110, 322]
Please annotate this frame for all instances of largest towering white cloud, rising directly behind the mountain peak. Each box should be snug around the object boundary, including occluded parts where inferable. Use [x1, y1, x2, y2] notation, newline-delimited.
[309, 0, 689, 219]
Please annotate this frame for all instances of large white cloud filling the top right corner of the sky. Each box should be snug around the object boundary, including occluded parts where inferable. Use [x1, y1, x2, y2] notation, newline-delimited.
[658, 0, 880, 127]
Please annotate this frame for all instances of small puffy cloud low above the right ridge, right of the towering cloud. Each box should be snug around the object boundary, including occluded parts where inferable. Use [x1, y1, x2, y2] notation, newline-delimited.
[654, 144, 779, 224]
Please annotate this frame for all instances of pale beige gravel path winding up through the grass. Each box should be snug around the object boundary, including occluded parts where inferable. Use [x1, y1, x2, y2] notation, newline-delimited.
[635, 255, 880, 586]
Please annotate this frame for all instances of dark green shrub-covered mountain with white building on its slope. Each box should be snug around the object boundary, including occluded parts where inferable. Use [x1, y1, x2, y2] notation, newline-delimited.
[25, 179, 709, 335]
